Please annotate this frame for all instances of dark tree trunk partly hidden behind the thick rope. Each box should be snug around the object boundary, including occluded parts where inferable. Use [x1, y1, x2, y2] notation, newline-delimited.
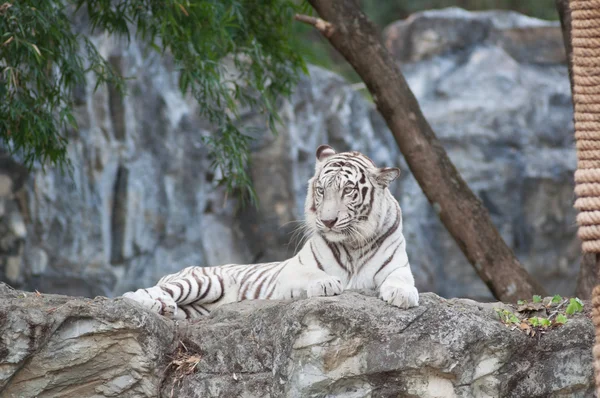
[556, 0, 600, 300]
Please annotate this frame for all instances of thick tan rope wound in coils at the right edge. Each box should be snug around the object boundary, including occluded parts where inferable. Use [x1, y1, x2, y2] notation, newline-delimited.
[569, 0, 600, 397]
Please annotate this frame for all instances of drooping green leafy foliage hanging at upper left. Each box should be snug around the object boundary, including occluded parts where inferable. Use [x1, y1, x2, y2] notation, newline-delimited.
[0, 0, 306, 202]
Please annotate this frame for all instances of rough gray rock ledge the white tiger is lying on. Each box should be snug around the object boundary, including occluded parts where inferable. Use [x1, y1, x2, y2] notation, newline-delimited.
[0, 285, 594, 398]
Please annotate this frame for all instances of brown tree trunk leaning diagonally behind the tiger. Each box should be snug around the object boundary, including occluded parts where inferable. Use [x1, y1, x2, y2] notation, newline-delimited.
[302, 0, 544, 302]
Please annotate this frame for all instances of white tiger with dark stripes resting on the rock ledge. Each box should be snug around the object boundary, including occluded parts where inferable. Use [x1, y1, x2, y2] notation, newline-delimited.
[123, 145, 419, 319]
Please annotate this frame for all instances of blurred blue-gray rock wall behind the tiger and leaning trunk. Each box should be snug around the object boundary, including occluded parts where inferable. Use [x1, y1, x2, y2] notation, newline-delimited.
[0, 9, 579, 299]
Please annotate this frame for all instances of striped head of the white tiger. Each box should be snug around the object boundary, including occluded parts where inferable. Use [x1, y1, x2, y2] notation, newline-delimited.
[305, 145, 400, 242]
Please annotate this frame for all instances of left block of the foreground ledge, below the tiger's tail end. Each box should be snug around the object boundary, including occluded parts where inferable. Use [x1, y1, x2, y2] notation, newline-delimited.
[0, 284, 177, 398]
